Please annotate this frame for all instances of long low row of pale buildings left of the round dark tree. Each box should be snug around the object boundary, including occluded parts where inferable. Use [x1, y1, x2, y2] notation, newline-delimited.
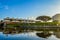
[4, 18, 35, 23]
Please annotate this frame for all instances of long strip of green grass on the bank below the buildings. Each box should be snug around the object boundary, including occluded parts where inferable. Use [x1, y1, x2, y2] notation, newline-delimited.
[7, 22, 57, 27]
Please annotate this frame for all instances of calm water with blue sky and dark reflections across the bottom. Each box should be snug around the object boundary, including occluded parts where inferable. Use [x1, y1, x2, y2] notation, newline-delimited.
[0, 29, 60, 40]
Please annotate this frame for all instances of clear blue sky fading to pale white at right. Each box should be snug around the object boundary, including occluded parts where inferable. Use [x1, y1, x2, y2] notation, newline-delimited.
[0, 0, 60, 19]
